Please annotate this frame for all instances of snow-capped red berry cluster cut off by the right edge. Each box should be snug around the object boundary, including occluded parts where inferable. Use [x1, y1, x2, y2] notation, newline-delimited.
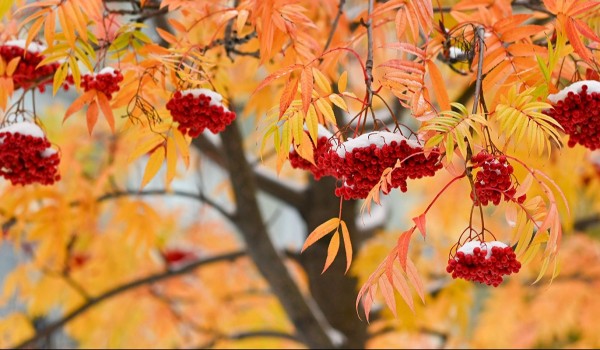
[544, 80, 600, 150]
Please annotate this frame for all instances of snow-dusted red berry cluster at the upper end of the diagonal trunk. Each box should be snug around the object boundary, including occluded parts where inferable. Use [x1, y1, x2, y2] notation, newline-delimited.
[167, 89, 235, 137]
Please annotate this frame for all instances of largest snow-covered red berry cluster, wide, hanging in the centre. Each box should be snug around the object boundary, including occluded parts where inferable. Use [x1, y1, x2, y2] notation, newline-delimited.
[321, 131, 442, 200]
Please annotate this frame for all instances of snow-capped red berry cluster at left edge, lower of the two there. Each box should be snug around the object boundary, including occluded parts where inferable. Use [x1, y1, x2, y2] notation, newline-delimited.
[0, 122, 60, 185]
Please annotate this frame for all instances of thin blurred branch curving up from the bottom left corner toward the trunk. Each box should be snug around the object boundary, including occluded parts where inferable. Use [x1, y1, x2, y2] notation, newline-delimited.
[9, 251, 246, 349]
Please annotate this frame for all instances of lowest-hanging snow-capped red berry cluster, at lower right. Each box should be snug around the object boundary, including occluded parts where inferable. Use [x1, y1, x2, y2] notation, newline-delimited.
[446, 241, 521, 287]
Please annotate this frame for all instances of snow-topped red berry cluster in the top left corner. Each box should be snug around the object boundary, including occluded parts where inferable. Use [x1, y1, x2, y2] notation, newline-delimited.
[0, 40, 59, 92]
